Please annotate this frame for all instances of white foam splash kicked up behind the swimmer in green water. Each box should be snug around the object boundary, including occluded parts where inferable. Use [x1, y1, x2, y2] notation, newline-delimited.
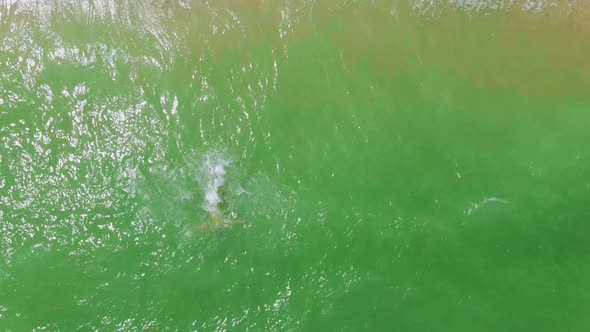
[203, 153, 229, 213]
